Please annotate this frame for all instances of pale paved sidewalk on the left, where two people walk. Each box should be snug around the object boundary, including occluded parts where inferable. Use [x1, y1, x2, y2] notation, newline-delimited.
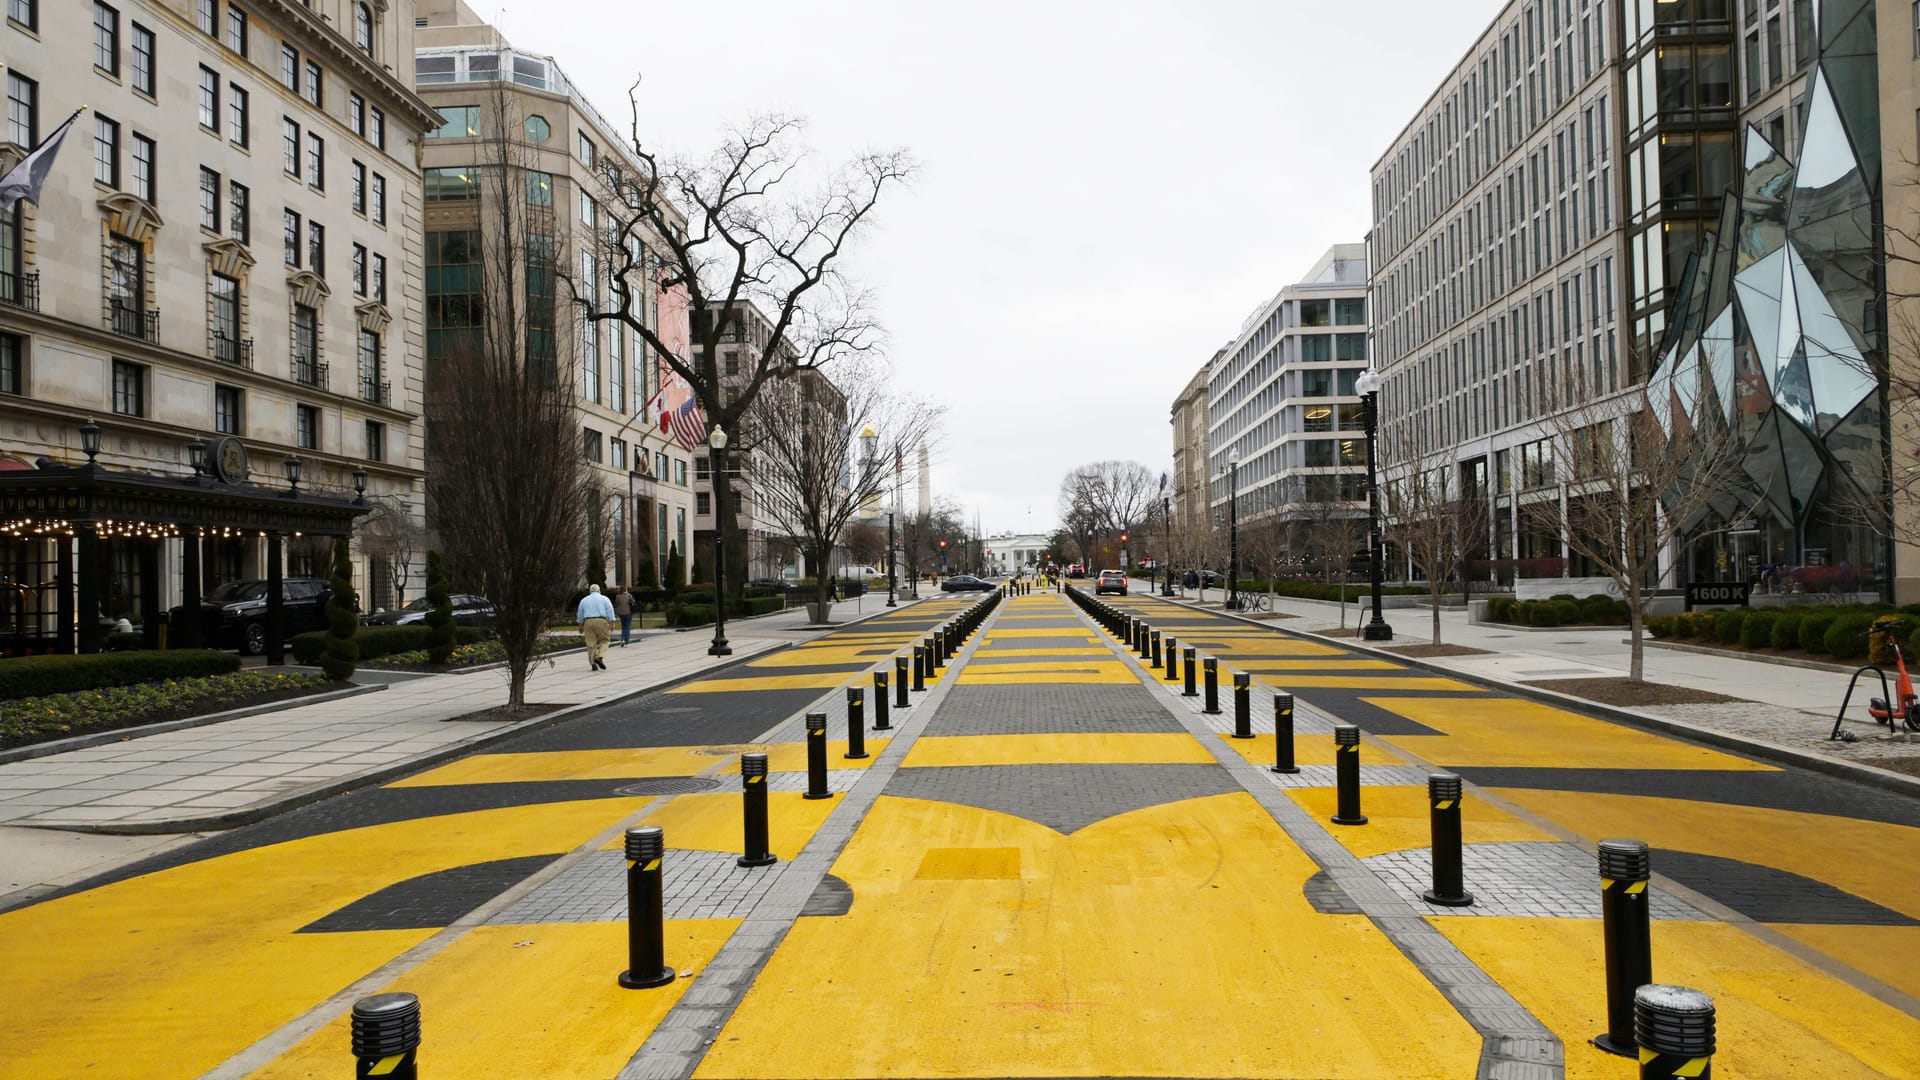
[0, 594, 921, 909]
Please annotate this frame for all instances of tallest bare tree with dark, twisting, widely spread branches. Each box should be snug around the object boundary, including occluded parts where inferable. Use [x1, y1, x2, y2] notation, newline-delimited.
[576, 109, 912, 599]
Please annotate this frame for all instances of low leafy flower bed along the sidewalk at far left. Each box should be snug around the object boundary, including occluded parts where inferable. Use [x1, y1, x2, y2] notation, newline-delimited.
[0, 671, 336, 749]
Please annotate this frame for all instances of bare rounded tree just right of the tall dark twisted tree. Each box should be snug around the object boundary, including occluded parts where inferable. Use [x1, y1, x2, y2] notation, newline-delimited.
[745, 363, 941, 621]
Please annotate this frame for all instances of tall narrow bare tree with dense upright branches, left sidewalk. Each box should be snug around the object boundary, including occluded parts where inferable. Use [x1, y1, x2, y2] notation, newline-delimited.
[426, 84, 595, 709]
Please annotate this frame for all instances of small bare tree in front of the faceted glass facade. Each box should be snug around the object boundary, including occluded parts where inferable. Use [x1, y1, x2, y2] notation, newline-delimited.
[1521, 382, 1751, 682]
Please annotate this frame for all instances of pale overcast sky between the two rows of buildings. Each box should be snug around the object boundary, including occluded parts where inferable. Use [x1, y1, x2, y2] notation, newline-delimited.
[491, 0, 1500, 532]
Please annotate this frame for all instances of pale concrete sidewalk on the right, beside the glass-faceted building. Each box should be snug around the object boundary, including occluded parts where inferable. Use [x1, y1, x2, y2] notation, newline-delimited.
[1175, 588, 1920, 780]
